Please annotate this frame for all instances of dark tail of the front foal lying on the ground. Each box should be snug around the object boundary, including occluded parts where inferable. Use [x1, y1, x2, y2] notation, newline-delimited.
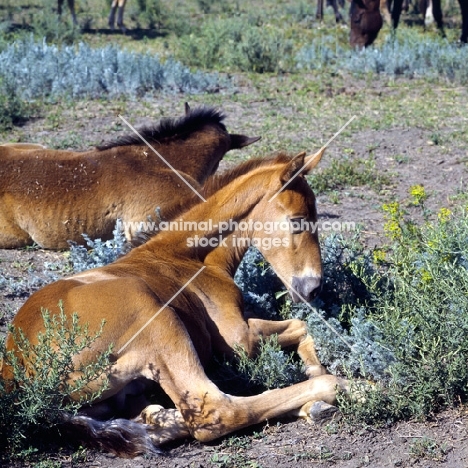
[63, 413, 162, 458]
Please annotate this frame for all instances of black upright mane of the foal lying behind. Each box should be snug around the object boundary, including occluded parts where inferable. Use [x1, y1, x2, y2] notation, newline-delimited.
[96, 106, 227, 151]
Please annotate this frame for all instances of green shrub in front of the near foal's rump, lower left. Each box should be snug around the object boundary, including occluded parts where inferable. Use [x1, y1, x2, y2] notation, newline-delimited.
[0, 306, 110, 459]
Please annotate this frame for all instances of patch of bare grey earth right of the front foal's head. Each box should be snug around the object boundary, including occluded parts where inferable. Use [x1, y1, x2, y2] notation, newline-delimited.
[318, 124, 466, 247]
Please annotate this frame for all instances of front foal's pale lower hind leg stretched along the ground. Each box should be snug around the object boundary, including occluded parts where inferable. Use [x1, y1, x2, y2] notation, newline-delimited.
[141, 375, 347, 445]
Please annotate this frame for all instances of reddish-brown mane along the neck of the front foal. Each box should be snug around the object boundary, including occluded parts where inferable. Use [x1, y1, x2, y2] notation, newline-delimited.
[132, 153, 293, 247]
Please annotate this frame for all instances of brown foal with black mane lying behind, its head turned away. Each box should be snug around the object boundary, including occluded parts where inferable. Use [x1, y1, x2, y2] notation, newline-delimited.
[0, 107, 258, 249]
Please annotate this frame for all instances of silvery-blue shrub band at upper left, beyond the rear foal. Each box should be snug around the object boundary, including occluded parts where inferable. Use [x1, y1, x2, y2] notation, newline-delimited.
[0, 38, 230, 98]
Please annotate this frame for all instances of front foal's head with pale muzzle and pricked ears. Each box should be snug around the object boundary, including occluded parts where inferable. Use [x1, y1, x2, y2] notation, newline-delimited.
[252, 150, 324, 302]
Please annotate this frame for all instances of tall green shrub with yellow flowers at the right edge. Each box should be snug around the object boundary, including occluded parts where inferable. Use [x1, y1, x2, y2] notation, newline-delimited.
[342, 192, 468, 417]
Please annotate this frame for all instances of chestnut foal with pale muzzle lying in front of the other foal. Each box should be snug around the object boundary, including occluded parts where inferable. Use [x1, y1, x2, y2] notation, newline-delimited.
[2, 151, 346, 456]
